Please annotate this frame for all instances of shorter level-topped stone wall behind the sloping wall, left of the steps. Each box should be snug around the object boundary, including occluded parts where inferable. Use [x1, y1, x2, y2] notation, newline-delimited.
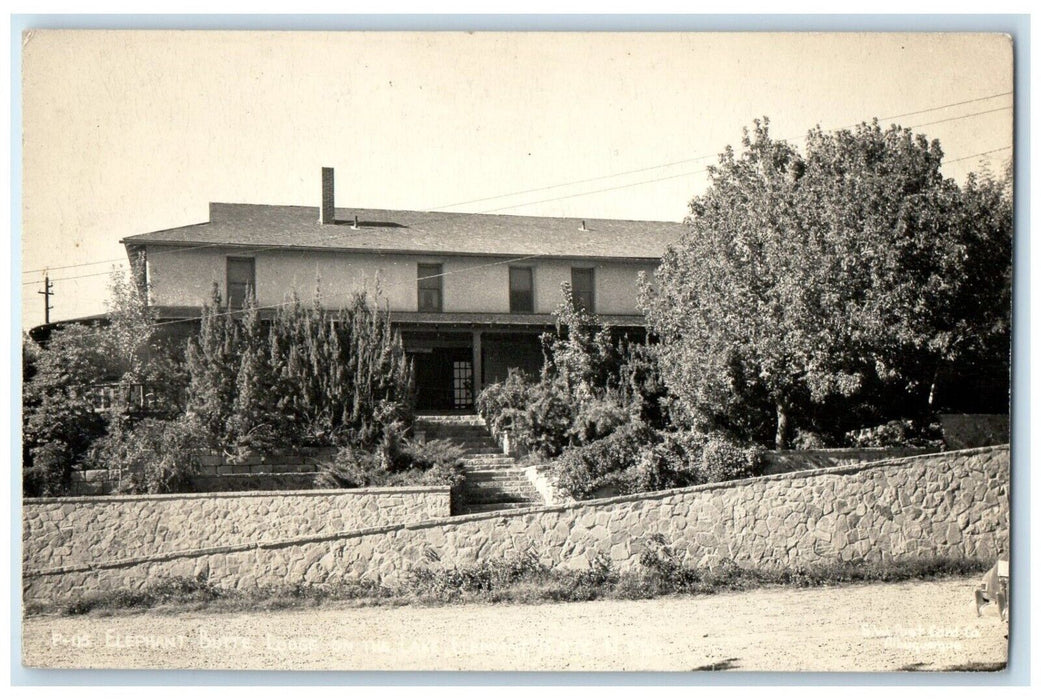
[22, 486, 451, 570]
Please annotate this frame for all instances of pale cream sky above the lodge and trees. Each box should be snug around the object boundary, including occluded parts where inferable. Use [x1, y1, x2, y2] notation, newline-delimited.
[21, 30, 1013, 327]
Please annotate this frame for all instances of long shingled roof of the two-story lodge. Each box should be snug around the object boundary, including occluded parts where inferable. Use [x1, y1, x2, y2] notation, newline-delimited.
[122, 203, 683, 259]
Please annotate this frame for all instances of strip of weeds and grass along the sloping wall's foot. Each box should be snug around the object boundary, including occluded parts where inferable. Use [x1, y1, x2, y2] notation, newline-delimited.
[25, 539, 989, 616]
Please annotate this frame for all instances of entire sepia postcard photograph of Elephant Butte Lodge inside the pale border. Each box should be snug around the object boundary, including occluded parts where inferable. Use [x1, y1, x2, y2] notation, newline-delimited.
[11, 29, 1011, 670]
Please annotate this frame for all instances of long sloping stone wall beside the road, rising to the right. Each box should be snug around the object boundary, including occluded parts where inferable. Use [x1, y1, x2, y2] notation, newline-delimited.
[24, 446, 1010, 600]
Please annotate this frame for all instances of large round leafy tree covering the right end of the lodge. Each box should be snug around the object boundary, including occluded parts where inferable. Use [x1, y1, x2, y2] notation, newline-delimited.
[641, 120, 1011, 448]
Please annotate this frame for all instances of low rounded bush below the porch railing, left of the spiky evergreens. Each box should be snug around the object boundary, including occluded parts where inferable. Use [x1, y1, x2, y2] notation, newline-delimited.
[86, 417, 205, 494]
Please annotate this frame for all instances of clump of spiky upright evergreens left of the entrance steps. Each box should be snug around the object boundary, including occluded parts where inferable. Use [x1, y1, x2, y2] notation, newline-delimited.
[188, 281, 413, 449]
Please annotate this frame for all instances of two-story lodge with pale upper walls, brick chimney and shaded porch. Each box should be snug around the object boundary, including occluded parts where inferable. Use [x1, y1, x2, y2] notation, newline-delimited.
[122, 168, 683, 410]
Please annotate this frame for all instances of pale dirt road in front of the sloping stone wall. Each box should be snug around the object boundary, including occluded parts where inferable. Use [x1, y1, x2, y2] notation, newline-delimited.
[23, 577, 1008, 671]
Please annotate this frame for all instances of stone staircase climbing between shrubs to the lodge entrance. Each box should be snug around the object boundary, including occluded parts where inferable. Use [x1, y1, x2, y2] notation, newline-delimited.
[414, 414, 542, 515]
